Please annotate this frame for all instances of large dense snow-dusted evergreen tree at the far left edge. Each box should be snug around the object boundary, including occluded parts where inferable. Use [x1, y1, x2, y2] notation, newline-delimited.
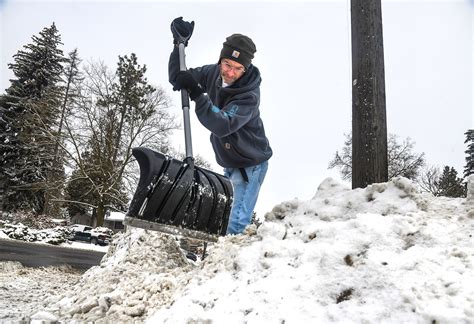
[0, 23, 64, 213]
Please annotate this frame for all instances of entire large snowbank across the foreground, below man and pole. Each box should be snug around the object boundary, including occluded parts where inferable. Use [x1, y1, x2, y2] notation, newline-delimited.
[31, 178, 474, 323]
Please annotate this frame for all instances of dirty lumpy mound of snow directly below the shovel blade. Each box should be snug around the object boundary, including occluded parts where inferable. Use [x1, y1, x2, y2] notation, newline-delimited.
[32, 229, 192, 323]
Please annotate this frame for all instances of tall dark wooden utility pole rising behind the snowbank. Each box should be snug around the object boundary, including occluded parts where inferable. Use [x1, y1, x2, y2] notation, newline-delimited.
[351, 0, 388, 188]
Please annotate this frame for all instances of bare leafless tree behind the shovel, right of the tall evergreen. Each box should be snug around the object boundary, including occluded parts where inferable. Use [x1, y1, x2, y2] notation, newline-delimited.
[59, 58, 177, 225]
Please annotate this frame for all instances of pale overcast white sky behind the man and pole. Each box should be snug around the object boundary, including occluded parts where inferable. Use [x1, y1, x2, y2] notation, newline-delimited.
[0, 0, 474, 216]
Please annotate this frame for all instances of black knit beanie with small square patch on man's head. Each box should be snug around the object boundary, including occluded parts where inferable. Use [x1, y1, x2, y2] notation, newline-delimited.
[219, 34, 257, 68]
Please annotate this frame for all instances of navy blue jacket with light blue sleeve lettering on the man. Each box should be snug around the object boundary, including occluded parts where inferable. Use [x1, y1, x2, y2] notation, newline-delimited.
[169, 48, 273, 168]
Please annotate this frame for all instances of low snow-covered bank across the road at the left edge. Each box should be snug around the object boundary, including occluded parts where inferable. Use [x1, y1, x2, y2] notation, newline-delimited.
[0, 220, 70, 245]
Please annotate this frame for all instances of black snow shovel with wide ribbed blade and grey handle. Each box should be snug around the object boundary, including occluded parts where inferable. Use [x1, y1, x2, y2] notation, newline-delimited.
[124, 27, 233, 242]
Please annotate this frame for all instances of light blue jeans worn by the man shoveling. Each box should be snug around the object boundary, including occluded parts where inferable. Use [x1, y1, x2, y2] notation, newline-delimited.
[224, 161, 268, 234]
